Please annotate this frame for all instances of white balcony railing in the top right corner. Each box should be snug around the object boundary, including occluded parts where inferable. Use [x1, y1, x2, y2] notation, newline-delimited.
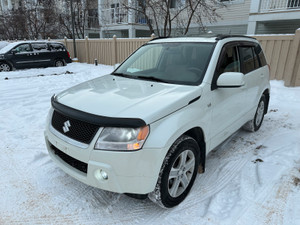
[260, 0, 300, 12]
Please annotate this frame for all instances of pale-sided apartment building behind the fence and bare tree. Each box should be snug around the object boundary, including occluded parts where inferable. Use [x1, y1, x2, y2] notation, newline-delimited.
[98, 0, 300, 38]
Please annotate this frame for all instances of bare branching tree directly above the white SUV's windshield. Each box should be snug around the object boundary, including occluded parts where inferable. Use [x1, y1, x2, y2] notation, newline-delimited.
[122, 0, 224, 37]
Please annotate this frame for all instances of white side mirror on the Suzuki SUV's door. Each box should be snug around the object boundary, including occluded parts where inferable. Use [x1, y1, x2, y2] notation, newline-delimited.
[217, 72, 245, 88]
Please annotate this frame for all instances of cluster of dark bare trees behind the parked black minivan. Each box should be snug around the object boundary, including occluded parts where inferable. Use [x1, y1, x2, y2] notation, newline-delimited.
[0, 0, 94, 39]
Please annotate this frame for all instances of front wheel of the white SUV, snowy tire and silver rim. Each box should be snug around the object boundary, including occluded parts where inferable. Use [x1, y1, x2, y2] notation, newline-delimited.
[149, 135, 200, 208]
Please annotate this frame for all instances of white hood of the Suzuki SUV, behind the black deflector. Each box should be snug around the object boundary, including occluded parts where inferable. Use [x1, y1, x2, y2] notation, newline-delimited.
[56, 75, 201, 124]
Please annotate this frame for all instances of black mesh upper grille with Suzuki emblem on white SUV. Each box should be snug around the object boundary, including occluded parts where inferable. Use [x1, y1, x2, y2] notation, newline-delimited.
[51, 110, 99, 144]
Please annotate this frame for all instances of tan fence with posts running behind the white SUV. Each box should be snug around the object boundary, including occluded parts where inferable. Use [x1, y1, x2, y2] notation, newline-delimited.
[61, 29, 300, 86]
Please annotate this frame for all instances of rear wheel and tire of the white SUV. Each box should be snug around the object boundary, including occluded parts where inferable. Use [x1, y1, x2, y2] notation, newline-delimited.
[243, 95, 267, 132]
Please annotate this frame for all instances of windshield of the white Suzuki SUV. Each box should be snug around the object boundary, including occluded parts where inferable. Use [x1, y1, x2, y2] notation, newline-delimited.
[113, 42, 215, 85]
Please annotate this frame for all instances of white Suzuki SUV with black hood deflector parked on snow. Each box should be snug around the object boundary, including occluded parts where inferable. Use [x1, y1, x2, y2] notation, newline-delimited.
[45, 35, 270, 208]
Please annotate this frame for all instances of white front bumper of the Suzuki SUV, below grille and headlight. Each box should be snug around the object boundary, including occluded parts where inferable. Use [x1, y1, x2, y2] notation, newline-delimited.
[45, 124, 165, 194]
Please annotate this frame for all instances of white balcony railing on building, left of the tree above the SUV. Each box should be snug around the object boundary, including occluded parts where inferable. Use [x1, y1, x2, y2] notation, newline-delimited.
[101, 7, 148, 25]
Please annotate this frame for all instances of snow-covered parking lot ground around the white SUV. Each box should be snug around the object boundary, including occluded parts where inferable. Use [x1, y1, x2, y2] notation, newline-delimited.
[0, 63, 300, 225]
